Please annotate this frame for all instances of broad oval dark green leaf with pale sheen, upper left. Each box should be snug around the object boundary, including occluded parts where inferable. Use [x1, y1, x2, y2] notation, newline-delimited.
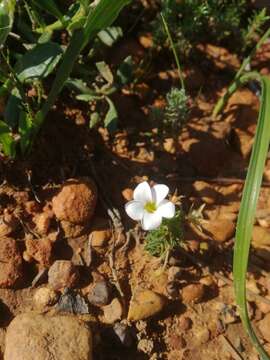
[15, 42, 62, 82]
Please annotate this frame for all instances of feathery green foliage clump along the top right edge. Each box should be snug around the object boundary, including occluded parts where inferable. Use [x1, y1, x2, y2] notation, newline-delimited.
[152, 0, 268, 55]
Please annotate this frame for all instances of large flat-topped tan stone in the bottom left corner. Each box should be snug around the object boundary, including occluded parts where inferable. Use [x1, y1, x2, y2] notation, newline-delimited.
[4, 313, 92, 360]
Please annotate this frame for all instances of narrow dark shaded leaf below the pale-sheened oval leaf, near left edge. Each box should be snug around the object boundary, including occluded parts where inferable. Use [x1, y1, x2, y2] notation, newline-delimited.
[4, 88, 22, 129]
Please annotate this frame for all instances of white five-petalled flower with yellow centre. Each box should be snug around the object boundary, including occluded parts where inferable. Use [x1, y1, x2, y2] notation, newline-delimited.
[125, 181, 175, 230]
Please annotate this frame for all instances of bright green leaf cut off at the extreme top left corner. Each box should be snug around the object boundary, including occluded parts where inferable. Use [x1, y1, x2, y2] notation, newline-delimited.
[0, 0, 16, 46]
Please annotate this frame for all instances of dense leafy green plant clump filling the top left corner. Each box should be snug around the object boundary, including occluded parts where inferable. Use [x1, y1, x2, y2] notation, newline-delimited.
[0, 0, 129, 157]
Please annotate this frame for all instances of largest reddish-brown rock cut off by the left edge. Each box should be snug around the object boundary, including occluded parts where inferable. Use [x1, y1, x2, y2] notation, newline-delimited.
[0, 237, 22, 288]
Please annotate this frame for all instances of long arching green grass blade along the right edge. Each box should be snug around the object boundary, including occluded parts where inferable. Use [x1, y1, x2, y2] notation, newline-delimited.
[233, 77, 270, 360]
